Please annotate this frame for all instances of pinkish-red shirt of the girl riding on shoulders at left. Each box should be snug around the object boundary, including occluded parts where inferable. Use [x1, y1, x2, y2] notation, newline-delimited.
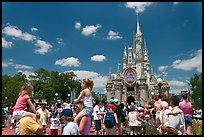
[14, 95, 30, 111]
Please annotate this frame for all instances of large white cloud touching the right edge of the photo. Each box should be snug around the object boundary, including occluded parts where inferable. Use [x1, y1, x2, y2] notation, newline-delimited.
[172, 49, 202, 72]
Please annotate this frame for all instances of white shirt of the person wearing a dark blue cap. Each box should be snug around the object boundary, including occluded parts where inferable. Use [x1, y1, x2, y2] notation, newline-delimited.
[62, 122, 80, 135]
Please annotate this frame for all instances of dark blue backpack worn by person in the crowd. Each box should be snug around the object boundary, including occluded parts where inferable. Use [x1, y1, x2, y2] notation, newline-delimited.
[104, 112, 116, 128]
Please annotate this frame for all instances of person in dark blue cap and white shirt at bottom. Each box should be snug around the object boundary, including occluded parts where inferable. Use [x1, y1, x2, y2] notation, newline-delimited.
[60, 109, 80, 135]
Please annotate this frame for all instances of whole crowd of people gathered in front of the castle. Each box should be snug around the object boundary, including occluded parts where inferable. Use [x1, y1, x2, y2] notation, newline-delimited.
[2, 79, 202, 135]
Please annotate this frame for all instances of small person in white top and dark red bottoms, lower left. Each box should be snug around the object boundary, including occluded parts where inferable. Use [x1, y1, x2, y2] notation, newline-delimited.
[50, 112, 60, 135]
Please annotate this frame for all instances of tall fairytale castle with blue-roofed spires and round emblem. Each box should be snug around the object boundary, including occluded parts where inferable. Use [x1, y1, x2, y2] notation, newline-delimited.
[106, 15, 170, 105]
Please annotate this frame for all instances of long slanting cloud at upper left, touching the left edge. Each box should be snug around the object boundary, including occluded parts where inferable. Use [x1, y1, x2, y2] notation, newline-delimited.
[3, 24, 36, 41]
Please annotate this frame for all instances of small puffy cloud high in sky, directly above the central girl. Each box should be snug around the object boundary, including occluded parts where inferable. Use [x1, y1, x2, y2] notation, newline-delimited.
[81, 24, 102, 36]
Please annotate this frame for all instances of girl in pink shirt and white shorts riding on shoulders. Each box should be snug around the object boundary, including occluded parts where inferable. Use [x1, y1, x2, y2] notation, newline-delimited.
[13, 84, 36, 120]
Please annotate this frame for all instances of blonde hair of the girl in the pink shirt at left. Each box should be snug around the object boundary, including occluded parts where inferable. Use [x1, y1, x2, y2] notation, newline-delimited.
[19, 83, 34, 97]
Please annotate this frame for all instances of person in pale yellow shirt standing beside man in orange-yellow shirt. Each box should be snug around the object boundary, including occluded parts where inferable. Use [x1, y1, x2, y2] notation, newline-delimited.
[37, 104, 50, 134]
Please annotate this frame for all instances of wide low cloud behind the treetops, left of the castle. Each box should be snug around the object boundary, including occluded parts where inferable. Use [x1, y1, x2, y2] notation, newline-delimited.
[65, 70, 108, 91]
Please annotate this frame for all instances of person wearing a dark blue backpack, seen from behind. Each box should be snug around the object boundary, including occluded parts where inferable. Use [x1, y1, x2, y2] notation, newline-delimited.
[103, 104, 118, 135]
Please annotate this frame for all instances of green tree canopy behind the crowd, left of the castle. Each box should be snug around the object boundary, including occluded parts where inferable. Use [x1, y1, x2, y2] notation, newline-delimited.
[2, 68, 81, 104]
